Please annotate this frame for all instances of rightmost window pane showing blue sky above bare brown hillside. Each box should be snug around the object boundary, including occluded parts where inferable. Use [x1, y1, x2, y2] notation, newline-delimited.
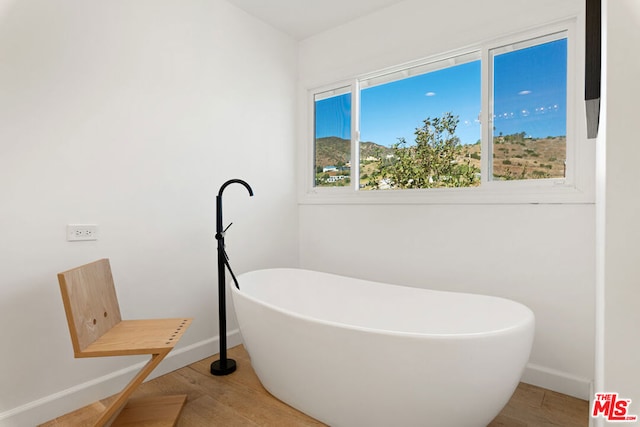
[492, 38, 567, 180]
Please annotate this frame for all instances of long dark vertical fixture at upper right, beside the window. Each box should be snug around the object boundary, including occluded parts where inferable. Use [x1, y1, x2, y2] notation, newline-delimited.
[584, 0, 602, 138]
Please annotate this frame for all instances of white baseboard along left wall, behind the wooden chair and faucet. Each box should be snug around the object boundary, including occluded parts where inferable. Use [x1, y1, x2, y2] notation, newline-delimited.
[0, 329, 242, 427]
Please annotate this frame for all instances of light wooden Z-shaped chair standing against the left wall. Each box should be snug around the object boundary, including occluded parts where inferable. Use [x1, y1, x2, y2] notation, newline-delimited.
[58, 259, 192, 427]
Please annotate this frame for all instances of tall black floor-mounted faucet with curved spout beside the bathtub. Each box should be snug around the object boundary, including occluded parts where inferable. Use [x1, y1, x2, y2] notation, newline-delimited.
[211, 179, 253, 376]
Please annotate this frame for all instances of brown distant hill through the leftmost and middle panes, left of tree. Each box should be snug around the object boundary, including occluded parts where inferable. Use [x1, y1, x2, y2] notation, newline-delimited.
[316, 136, 392, 167]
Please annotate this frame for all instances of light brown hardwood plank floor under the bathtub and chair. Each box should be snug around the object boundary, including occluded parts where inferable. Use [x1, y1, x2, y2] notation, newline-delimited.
[42, 346, 589, 427]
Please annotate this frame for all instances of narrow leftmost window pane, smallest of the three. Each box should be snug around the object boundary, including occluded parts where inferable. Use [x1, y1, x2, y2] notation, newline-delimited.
[314, 87, 351, 187]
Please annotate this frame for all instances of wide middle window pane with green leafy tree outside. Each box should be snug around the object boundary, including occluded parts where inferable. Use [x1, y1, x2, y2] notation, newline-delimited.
[360, 57, 480, 189]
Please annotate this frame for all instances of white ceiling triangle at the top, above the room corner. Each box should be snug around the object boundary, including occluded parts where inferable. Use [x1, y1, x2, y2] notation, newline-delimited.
[228, 0, 403, 40]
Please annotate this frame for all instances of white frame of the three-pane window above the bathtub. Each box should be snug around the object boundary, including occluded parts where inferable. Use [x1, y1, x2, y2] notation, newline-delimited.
[299, 19, 594, 204]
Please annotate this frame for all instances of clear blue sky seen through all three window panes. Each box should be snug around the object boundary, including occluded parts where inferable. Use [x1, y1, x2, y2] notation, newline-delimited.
[316, 39, 567, 146]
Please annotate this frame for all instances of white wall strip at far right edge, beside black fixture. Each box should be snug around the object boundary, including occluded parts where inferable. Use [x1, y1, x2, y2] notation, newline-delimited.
[597, 0, 640, 418]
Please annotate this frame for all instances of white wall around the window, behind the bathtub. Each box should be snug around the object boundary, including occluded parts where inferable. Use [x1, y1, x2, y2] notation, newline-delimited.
[298, 0, 595, 398]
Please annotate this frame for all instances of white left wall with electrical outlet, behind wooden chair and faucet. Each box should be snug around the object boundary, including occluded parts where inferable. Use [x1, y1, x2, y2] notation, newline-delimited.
[0, 0, 298, 426]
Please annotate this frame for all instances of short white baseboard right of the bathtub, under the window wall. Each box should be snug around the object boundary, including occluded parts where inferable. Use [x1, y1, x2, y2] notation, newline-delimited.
[522, 363, 591, 400]
